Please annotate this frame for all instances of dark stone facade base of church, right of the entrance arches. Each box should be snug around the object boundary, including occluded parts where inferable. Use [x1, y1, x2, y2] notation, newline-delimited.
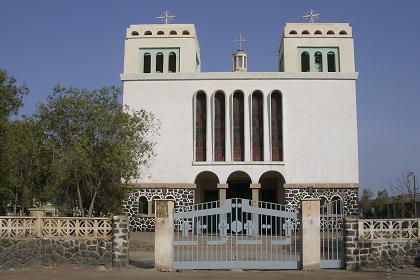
[285, 187, 359, 216]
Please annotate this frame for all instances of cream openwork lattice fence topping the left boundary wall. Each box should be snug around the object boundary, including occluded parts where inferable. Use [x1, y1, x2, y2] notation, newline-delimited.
[0, 217, 112, 239]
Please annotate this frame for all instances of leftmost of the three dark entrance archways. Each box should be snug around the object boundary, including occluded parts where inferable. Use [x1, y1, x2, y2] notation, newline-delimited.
[195, 171, 219, 203]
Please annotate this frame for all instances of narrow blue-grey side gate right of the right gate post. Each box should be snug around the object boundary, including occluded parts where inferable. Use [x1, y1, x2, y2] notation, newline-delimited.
[320, 200, 344, 268]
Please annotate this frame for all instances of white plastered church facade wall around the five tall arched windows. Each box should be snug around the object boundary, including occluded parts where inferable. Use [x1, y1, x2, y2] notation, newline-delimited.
[122, 72, 359, 184]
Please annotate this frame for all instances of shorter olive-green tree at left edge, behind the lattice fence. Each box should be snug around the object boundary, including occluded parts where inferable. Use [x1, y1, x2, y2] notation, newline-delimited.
[3, 118, 53, 215]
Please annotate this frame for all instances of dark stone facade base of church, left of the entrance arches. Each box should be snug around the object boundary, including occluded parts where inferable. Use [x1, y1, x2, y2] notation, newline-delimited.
[122, 188, 195, 231]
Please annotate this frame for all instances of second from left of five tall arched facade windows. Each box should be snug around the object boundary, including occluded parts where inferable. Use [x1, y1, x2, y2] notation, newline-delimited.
[211, 89, 229, 161]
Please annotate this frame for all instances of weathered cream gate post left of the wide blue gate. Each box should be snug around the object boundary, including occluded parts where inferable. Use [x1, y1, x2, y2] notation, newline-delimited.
[155, 199, 175, 271]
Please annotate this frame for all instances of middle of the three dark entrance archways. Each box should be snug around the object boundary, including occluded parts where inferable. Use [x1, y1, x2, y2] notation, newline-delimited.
[226, 171, 252, 199]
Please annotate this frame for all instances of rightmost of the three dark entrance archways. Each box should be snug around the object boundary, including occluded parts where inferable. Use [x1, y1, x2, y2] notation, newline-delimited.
[259, 171, 286, 204]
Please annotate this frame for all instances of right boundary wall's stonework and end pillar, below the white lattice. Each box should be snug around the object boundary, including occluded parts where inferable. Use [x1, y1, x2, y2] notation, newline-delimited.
[344, 219, 420, 270]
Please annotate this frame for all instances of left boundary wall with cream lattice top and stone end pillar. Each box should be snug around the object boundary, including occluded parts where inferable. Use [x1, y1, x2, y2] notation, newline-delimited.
[0, 216, 128, 270]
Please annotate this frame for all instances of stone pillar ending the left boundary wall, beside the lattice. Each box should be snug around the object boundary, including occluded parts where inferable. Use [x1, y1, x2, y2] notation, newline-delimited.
[112, 215, 128, 267]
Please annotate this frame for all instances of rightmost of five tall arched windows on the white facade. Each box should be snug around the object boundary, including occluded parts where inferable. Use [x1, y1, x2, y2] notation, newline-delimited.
[266, 89, 284, 161]
